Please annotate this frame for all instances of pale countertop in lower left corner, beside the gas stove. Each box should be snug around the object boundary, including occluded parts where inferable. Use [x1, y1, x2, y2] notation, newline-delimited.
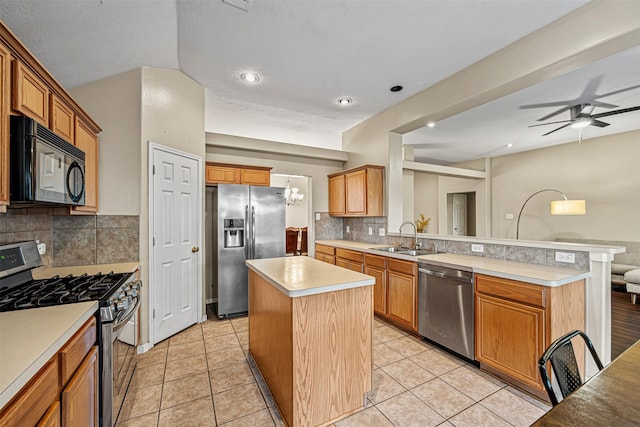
[0, 301, 98, 408]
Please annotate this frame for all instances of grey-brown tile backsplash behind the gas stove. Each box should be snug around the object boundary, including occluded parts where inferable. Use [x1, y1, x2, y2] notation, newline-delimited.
[0, 210, 140, 267]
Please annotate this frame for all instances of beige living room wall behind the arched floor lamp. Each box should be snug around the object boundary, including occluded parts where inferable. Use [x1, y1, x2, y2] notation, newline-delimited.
[491, 131, 640, 241]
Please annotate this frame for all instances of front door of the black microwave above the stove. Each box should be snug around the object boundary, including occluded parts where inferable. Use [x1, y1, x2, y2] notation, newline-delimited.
[32, 138, 85, 205]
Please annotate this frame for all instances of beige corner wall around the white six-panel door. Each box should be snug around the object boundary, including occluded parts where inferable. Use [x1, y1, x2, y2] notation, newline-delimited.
[72, 67, 205, 343]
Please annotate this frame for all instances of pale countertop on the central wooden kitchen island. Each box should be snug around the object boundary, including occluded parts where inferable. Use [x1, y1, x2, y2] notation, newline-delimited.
[246, 256, 375, 298]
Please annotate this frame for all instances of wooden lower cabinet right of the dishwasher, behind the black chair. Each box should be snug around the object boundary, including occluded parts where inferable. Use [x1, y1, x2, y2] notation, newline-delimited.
[475, 274, 584, 400]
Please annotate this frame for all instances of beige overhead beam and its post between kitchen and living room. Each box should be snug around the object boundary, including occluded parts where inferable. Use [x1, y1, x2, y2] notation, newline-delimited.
[342, 1, 640, 235]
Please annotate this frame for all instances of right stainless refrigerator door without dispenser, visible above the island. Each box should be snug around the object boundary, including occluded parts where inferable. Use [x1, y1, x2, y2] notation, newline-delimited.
[249, 187, 285, 259]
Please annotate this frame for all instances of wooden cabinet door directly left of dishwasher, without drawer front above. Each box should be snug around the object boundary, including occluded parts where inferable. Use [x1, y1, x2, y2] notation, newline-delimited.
[387, 270, 418, 331]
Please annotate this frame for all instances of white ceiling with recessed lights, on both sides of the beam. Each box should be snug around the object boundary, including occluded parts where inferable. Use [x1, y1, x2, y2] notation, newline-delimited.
[0, 0, 640, 163]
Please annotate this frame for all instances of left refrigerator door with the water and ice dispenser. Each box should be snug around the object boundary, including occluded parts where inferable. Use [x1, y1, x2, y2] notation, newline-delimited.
[216, 184, 249, 317]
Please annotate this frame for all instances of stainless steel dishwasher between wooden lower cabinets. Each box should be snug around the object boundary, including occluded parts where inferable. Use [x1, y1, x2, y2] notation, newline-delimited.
[418, 263, 474, 360]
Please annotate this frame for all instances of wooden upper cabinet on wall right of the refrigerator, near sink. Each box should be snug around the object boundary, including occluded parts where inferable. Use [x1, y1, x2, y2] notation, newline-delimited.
[329, 165, 384, 216]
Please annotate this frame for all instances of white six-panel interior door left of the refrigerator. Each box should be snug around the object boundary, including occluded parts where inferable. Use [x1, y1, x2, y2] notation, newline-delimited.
[151, 147, 202, 344]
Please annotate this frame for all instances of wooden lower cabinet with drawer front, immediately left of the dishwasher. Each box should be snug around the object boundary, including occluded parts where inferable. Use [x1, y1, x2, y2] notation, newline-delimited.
[387, 259, 418, 332]
